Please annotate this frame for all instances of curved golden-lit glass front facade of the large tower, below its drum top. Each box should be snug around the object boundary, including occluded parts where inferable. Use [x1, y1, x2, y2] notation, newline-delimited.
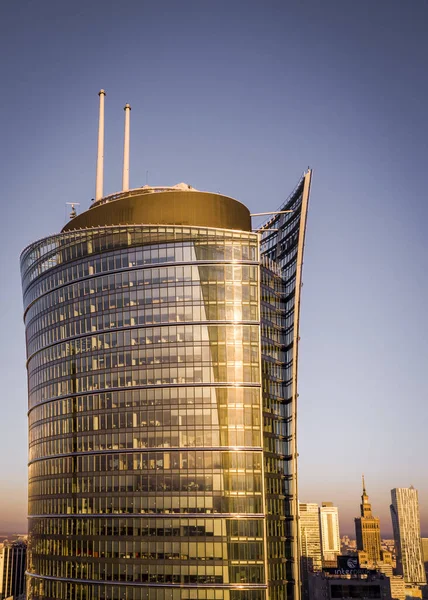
[22, 227, 266, 600]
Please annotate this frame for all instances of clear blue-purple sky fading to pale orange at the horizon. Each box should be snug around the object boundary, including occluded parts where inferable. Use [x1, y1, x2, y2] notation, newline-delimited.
[0, 0, 428, 535]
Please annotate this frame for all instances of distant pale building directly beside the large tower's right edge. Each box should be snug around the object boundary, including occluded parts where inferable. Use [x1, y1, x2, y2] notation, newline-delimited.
[299, 502, 322, 598]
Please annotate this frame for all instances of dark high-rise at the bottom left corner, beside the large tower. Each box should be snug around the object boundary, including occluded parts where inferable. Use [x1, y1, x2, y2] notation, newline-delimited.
[0, 540, 27, 599]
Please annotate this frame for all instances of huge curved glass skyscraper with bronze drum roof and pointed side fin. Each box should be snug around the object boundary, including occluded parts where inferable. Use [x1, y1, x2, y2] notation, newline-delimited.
[21, 171, 311, 600]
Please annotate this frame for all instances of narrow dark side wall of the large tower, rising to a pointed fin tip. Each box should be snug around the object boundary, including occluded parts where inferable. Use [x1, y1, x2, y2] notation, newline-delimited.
[259, 170, 312, 600]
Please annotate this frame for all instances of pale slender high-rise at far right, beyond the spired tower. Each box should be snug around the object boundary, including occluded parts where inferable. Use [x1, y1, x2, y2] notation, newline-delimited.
[391, 486, 426, 585]
